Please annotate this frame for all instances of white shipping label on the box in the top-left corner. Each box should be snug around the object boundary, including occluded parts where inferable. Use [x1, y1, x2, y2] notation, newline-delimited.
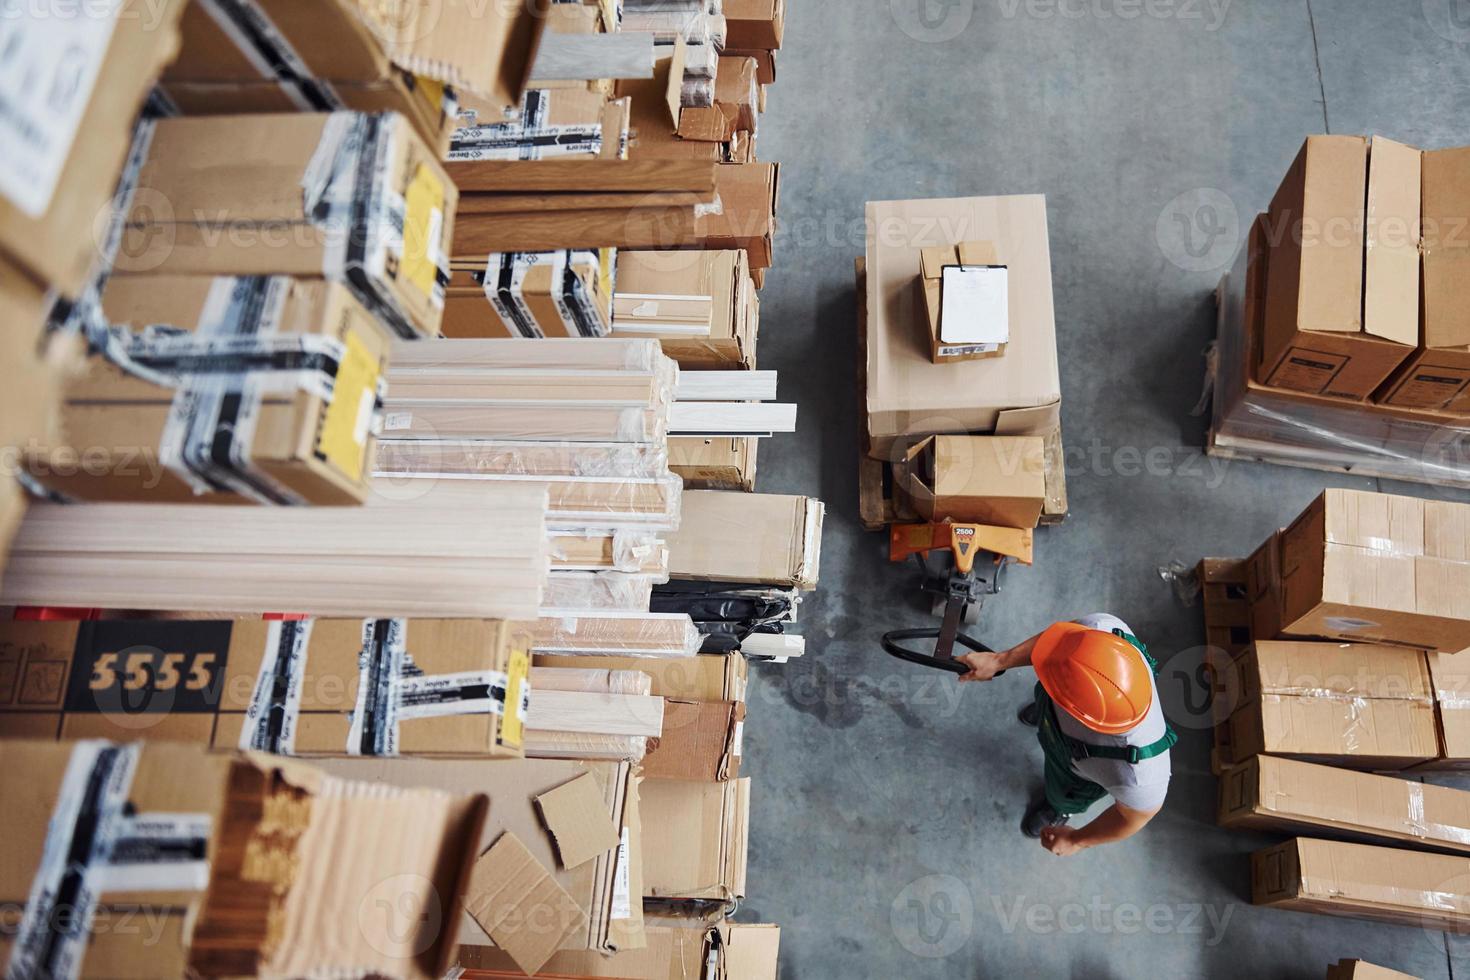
[0, 0, 122, 217]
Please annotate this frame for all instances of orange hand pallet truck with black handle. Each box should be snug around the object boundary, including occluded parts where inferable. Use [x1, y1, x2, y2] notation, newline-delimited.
[882, 523, 1032, 676]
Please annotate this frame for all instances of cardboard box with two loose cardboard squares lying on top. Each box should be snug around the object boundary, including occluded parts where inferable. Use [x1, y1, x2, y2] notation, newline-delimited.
[319, 758, 648, 974]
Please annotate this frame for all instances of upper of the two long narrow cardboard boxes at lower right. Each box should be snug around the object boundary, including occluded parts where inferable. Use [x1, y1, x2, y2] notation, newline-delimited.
[1219, 755, 1470, 854]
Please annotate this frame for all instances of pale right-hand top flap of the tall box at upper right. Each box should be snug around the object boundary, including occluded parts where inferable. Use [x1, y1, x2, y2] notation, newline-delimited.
[1363, 137, 1421, 347]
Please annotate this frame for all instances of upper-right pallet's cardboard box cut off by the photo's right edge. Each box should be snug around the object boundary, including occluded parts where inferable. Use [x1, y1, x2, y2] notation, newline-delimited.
[1379, 147, 1470, 414]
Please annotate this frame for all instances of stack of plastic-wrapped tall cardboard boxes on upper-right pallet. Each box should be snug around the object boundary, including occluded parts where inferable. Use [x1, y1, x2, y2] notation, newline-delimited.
[1210, 137, 1470, 486]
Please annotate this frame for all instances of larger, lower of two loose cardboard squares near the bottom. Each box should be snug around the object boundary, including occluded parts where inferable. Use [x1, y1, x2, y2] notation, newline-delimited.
[465, 832, 588, 974]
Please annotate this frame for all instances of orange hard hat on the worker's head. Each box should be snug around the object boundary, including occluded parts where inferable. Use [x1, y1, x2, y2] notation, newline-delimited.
[1030, 623, 1154, 735]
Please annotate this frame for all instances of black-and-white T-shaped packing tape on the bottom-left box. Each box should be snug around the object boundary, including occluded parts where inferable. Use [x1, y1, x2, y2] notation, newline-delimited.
[4, 739, 210, 980]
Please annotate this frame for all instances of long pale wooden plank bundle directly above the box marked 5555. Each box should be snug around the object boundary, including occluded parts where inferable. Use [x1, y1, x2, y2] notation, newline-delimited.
[0, 483, 548, 619]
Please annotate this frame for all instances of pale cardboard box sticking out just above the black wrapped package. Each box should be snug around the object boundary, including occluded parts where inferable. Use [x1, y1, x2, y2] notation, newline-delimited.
[666, 491, 826, 591]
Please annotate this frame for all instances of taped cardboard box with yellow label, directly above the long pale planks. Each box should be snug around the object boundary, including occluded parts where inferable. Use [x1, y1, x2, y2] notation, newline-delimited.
[24, 276, 390, 504]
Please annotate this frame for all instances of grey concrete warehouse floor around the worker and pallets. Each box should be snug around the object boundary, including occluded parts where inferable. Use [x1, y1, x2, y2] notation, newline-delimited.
[742, 0, 1470, 980]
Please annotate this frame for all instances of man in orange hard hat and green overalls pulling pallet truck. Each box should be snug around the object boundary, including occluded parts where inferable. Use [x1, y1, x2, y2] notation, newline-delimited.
[958, 614, 1179, 857]
